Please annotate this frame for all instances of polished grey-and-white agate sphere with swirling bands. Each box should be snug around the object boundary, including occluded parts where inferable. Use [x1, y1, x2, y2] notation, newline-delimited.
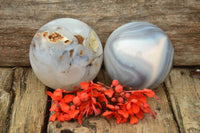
[104, 22, 174, 89]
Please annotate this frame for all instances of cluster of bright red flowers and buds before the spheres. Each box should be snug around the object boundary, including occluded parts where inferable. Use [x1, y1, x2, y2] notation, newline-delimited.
[47, 80, 160, 124]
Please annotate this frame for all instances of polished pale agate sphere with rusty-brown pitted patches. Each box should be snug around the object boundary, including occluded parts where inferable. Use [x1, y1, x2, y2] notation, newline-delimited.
[29, 18, 103, 90]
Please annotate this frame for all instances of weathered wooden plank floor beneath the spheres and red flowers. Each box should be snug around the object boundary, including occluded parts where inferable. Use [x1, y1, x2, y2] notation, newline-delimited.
[0, 68, 200, 133]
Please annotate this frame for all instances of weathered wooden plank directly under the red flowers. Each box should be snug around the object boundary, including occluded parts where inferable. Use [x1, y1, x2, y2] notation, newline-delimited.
[48, 70, 178, 133]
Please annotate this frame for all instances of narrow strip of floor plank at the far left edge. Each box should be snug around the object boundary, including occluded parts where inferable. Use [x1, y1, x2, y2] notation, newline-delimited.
[0, 68, 13, 133]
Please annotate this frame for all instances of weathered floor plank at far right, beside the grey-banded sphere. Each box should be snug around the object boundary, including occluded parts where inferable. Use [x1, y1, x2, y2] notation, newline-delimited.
[166, 68, 200, 133]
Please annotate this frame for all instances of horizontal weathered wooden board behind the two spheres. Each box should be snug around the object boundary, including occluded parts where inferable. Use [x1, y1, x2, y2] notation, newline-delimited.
[0, 0, 200, 66]
